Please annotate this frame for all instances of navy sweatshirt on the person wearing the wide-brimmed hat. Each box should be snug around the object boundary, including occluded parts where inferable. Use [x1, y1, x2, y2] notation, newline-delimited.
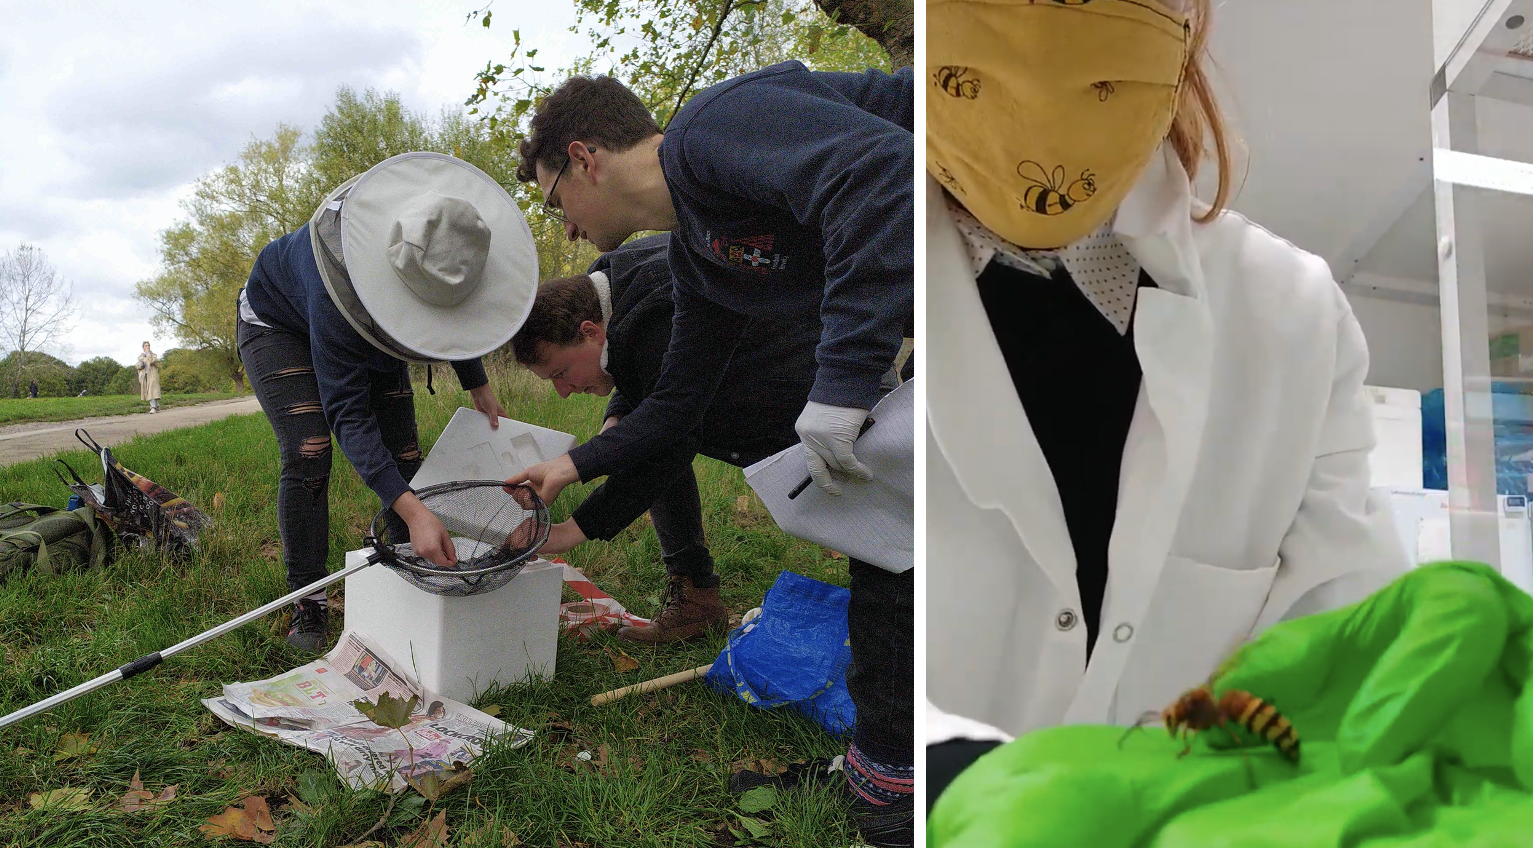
[245, 224, 488, 505]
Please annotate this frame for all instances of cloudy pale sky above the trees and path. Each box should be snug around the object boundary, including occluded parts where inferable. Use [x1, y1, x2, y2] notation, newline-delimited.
[0, 0, 584, 364]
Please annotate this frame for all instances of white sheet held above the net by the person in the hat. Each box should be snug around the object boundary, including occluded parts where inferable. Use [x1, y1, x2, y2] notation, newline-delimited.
[410, 407, 575, 489]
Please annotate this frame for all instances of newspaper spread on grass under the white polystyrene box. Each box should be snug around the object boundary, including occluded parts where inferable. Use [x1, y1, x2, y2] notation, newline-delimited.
[202, 632, 532, 792]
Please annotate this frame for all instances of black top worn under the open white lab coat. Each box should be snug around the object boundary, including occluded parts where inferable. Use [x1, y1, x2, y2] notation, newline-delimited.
[979, 262, 1155, 658]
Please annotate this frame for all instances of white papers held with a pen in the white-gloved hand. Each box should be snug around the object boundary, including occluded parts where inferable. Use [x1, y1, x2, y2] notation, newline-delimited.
[746, 381, 916, 572]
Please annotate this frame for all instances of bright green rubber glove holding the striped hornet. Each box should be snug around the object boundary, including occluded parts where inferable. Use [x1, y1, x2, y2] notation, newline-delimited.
[927, 563, 1534, 847]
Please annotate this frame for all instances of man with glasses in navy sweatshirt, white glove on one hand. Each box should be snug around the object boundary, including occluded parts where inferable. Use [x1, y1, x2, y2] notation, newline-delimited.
[508, 61, 916, 845]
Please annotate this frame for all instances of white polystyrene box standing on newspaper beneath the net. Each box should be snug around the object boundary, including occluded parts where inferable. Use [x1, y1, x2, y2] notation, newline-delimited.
[345, 549, 565, 703]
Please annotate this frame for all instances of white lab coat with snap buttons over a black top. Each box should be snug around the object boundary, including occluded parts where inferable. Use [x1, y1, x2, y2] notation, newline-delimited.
[927, 146, 1407, 735]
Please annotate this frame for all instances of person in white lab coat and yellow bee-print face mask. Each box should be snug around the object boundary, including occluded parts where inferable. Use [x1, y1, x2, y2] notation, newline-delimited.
[927, 0, 1407, 764]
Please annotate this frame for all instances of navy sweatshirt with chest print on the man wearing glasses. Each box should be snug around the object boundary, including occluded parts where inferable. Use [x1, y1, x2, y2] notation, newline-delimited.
[571, 61, 916, 482]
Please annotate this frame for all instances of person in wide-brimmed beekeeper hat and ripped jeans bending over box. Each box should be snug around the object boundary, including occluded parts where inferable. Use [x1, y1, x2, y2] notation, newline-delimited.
[236, 152, 538, 652]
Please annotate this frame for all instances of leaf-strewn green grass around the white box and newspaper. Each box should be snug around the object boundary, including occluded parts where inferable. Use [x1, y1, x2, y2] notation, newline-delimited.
[0, 371, 858, 847]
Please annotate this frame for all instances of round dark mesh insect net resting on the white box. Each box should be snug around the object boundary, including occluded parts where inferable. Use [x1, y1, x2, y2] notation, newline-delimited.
[368, 482, 549, 597]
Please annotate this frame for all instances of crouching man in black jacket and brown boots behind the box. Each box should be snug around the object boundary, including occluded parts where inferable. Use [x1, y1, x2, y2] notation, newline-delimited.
[512, 233, 821, 643]
